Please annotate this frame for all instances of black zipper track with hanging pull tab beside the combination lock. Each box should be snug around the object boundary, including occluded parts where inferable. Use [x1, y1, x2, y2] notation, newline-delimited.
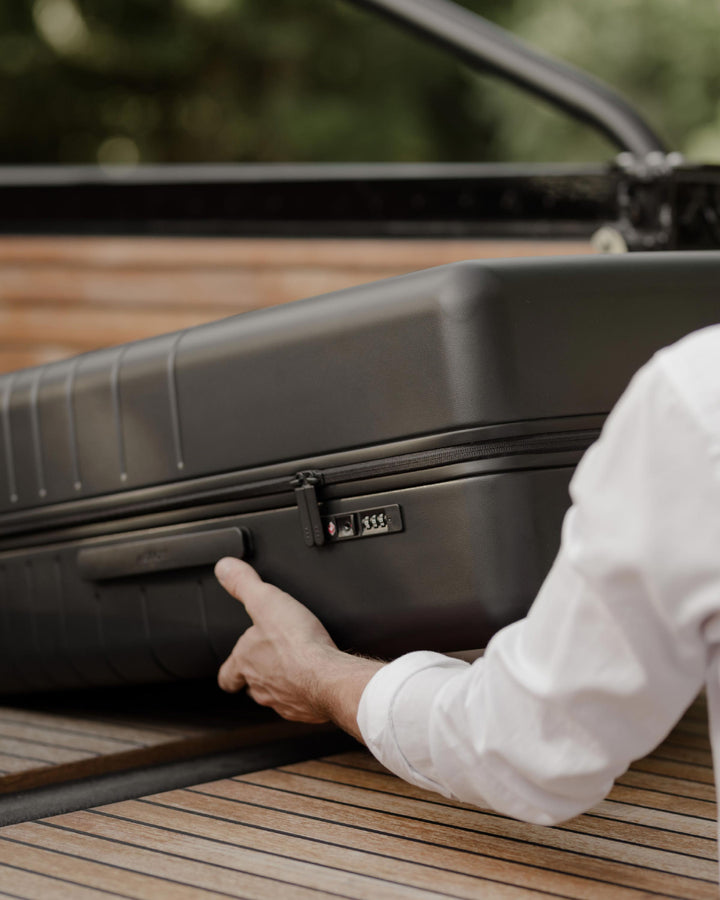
[290, 428, 600, 547]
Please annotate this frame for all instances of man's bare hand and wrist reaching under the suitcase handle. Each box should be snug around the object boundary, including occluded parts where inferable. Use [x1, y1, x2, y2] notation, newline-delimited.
[215, 557, 382, 737]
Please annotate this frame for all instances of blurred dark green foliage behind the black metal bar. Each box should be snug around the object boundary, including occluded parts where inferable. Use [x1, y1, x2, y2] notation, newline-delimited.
[0, 0, 720, 163]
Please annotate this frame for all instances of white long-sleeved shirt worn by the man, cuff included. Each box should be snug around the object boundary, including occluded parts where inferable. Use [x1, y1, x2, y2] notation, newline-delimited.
[358, 326, 720, 825]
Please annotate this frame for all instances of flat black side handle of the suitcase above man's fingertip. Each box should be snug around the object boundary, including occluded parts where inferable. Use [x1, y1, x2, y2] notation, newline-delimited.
[77, 528, 250, 581]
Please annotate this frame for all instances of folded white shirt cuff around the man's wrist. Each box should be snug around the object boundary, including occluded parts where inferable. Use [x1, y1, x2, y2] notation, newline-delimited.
[357, 650, 469, 796]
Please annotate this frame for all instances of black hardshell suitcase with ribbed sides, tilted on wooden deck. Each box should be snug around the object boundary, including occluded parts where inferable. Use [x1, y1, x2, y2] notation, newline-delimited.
[0, 253, 720, 692]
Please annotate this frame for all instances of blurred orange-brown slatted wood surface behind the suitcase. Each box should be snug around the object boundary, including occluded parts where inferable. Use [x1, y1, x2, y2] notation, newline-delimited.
[0, 237, 590, 372]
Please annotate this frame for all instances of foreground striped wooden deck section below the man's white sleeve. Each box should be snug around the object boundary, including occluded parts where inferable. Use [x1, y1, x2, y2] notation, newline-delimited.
[0, 701, 718, 900]
